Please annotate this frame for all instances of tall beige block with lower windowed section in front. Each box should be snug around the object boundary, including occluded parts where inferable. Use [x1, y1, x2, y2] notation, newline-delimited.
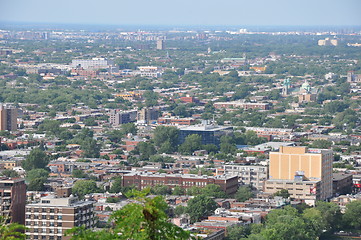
[265, 146, 333, 200]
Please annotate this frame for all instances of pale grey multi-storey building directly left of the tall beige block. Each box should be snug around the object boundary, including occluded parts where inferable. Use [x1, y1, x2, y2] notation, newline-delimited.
[217, 164, 268, 190]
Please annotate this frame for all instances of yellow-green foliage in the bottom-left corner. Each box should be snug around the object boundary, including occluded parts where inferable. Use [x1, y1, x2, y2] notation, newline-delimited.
[0, 216, 26, 240]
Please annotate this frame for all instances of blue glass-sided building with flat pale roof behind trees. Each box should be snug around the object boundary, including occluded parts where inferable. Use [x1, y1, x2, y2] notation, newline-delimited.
[179, 124, 233, 146]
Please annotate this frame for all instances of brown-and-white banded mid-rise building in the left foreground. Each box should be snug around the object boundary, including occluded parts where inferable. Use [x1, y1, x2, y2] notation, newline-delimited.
[25, 195, 95, 240]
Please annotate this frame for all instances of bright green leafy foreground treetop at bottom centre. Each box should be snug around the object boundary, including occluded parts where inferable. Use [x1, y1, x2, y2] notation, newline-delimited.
[67, 189, 193, 240]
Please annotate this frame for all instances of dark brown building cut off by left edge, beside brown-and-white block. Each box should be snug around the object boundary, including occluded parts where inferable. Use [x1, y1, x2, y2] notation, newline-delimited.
[0, 178, 26, 224]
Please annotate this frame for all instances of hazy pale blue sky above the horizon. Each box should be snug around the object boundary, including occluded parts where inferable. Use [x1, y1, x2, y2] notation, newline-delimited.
[0, 0, 361, 26]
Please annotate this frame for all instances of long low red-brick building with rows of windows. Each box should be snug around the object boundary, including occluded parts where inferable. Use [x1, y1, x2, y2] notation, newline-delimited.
[122, 172, 238, 194]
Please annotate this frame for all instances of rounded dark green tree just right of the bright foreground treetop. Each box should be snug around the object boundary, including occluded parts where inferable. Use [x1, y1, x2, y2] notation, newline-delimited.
[187, 195, 218, 223]
